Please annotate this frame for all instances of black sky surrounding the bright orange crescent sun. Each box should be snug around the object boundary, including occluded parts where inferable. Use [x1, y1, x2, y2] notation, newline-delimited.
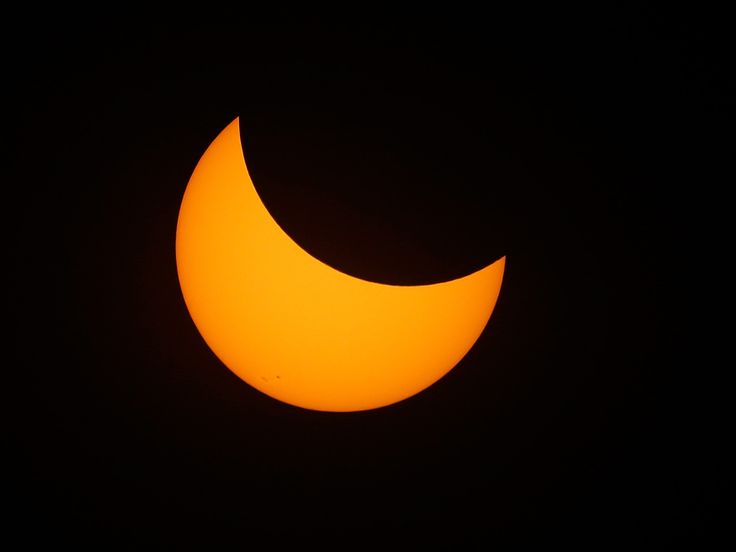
[3, 7, 730, 550]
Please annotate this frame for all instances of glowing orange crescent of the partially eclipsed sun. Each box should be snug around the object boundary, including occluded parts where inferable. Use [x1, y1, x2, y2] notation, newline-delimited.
[176, 119, 505, 412]
